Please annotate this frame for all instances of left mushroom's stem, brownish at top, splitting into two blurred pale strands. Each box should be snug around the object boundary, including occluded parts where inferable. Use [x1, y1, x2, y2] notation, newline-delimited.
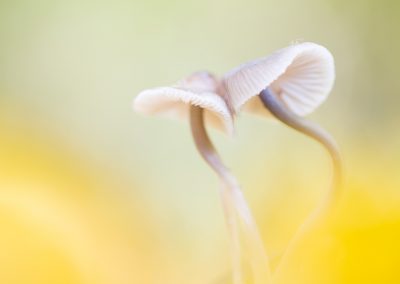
[190, 106, 271, 284]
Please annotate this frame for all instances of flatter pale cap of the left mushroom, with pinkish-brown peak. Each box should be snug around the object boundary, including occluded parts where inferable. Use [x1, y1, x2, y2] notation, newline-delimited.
[133, 72, 233, 135]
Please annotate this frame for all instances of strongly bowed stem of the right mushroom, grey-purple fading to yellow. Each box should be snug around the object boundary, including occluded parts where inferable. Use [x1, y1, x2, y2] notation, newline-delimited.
[260, 88, 343, 272]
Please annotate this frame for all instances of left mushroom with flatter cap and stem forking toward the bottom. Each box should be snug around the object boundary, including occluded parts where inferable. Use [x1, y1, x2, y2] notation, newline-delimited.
[133, 72, 270, 284]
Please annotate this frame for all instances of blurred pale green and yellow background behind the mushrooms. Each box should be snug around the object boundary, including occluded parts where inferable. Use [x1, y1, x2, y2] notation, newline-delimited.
[0, 0, 400, 284]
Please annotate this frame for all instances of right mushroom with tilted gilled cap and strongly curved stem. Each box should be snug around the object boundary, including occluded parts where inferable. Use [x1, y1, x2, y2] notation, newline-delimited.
[223, 42, 342, 270]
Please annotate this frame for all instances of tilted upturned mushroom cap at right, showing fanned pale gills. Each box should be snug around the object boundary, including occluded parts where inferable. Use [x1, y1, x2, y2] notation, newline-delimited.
[223, 42, 335, 116]
